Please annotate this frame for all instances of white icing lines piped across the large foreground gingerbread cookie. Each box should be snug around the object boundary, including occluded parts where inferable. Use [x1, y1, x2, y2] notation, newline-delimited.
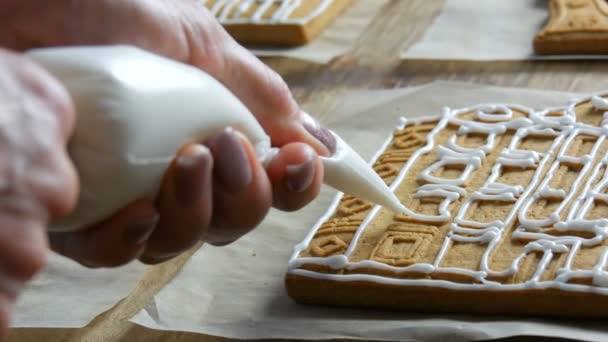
[288, 94, 608, 295]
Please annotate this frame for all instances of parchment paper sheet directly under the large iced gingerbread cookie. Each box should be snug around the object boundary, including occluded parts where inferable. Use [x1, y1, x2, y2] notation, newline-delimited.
[132, 82, 608, 341]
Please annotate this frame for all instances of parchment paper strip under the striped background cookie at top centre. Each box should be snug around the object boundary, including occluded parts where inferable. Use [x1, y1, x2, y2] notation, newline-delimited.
[250, 0, 388, 63]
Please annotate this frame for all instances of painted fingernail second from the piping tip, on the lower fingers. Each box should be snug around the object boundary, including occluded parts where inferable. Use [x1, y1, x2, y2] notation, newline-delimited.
[211, 127, 253, 193]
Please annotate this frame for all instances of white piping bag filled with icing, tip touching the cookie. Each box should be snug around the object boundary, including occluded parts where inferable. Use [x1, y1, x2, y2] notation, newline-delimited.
[27, 46, 404, 232]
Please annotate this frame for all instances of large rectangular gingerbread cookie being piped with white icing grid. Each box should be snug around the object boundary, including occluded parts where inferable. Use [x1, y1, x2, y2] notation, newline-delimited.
[286, 94, 608, 317]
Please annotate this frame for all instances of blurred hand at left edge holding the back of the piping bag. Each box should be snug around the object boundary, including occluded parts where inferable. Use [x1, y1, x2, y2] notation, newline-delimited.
[0, 49, 77, 339]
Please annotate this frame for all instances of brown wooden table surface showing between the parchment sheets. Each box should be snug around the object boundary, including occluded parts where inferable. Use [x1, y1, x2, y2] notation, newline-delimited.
[8, 0, 608, 342]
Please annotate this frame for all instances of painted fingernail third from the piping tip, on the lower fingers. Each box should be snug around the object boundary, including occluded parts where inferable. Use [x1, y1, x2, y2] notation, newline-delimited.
[175, 144, 211, 208]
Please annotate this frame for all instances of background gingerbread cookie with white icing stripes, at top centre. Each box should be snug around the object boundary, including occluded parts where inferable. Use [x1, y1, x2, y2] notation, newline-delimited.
[203, 0, 352, 46]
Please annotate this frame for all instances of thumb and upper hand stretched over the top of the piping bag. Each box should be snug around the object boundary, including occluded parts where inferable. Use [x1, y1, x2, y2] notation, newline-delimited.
[0, 1, 331, 155]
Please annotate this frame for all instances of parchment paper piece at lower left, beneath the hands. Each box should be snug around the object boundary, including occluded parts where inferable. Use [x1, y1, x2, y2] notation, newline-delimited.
[12, 254, 145, 328]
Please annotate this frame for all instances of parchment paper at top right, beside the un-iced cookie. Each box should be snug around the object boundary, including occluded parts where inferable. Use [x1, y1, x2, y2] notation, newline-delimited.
[401, 0, 608, 61]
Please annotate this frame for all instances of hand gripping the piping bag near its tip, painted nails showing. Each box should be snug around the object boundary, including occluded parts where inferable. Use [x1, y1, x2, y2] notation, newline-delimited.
[0, 0, 335, 267]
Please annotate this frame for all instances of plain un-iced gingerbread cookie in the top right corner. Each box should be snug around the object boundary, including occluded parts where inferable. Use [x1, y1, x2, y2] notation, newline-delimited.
[534, 0, 608, 55]
